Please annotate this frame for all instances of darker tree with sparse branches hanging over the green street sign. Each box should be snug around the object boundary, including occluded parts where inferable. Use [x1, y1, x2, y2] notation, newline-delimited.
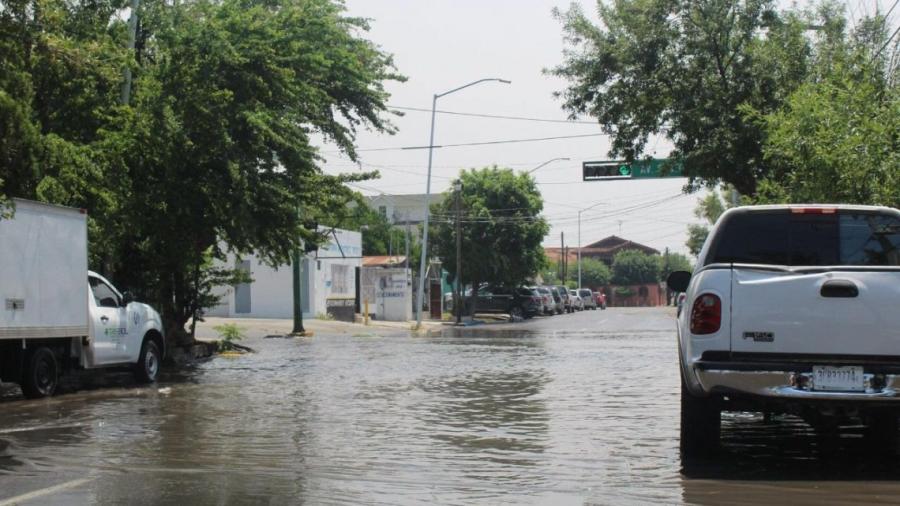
[550, 0, 811, 194]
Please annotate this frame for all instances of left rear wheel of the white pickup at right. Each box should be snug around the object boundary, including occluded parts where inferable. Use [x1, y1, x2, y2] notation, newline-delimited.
[681, 373, 722, 457]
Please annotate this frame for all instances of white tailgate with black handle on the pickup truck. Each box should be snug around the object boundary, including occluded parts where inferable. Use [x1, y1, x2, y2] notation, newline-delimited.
[731, 267, 900, 356]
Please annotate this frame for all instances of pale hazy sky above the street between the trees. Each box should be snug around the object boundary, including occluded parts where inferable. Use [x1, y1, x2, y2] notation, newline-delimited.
[322, 0, 892, 253]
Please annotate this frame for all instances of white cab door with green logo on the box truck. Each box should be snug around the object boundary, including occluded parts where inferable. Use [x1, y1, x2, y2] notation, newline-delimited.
[88, 276, 128, 365]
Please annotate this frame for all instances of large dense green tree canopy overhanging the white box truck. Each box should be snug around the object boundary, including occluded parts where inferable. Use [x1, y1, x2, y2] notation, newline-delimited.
[0, 0, 402, 344]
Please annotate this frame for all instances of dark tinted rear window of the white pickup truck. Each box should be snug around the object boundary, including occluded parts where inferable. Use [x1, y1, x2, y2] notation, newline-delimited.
[706, 210, 900, 266]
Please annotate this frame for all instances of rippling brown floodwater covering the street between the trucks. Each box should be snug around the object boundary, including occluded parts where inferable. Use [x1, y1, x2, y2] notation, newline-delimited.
[0, 310, 900, 505]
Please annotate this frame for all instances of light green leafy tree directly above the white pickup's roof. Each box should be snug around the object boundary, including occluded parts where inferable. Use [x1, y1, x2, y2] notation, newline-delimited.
[748, 18, 900, 207]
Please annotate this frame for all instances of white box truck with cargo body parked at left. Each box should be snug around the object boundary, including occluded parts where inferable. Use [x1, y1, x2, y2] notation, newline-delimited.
[0, 199, 165, 398]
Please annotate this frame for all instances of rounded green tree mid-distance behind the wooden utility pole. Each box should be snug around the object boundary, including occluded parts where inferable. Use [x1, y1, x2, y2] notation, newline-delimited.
[432, 166, 550, 308]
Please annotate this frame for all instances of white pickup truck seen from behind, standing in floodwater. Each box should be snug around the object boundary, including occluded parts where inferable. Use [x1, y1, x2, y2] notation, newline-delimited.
[668, 205, 900, 454]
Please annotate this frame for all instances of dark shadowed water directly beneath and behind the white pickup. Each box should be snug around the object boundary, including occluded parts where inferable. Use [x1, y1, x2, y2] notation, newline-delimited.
[681, 413, 900, 504]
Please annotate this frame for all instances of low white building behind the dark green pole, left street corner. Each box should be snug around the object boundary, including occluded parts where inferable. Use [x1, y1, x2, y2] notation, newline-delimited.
[206, 227, 362, 318]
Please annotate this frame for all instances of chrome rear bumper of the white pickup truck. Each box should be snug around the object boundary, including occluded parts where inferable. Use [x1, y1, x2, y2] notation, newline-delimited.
[694, 365, 900, 403]
